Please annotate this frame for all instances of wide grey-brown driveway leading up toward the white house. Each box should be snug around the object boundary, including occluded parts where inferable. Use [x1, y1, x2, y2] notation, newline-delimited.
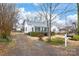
[3, 34, 76, 56]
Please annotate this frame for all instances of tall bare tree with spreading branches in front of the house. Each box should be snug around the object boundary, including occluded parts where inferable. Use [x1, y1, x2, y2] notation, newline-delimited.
[38, 3, 74, 40]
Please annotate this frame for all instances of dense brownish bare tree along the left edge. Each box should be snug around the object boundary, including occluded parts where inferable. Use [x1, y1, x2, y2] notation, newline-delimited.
[0, 3, 16, 38]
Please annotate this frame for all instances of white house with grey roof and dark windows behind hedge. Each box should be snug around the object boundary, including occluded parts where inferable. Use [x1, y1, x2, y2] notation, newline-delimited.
[24, 21, 47, 33]
